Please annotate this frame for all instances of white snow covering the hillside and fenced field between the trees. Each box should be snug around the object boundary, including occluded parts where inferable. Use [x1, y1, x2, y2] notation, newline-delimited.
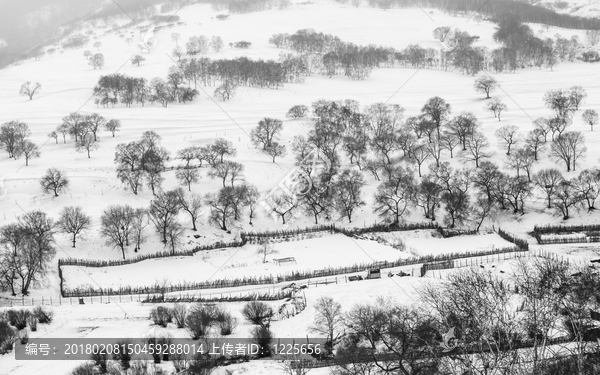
[0, 1, 600, 375]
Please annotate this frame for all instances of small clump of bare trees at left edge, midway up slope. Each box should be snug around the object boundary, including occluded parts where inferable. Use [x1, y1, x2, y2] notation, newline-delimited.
[0, 120, 40, 166]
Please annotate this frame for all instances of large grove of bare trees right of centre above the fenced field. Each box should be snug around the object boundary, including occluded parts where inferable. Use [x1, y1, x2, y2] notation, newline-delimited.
[280, 86, 600, 230]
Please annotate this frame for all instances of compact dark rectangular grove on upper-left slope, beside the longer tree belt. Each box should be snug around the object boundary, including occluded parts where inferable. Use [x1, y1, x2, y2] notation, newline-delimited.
[94, 70, 198, 107]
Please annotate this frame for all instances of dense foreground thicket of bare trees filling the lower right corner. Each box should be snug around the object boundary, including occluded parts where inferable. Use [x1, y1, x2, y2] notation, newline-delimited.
[326, 258, 600, 375]
